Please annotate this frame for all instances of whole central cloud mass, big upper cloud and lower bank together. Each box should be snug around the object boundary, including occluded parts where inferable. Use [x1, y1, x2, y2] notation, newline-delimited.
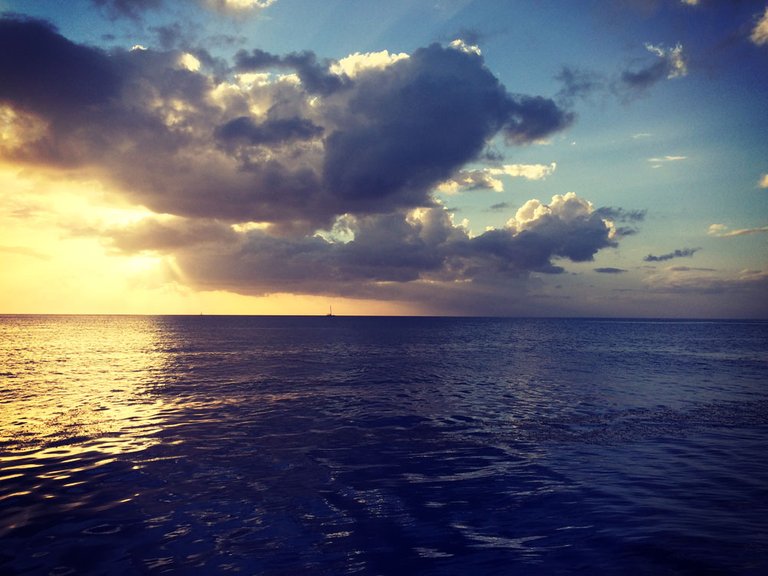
[0, 18, 616, 308]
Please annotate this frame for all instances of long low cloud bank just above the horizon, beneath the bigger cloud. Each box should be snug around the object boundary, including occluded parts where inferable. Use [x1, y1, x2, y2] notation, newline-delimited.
[103, 193, 616, 298]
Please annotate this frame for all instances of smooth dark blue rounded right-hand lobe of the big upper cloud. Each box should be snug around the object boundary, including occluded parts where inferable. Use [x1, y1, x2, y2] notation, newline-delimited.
[323, 44, 572, 210]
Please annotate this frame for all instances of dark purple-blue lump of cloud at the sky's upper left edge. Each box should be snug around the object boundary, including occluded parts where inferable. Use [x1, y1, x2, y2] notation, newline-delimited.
[0, 17, 121, 119]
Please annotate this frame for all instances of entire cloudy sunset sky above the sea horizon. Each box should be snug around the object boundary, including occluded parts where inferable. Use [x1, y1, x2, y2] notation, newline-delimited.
[0, 0, 768, 318]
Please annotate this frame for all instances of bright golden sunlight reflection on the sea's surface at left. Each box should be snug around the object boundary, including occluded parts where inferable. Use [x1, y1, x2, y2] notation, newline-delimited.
[0, 316, 170, 458]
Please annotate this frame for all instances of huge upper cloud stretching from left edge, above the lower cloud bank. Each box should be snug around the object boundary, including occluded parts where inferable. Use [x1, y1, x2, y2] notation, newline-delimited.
[0, 19, 571, 233]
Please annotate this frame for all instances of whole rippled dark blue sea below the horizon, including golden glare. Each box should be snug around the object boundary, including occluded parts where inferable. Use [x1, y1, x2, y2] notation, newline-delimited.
[0, 316, 768, 576]
